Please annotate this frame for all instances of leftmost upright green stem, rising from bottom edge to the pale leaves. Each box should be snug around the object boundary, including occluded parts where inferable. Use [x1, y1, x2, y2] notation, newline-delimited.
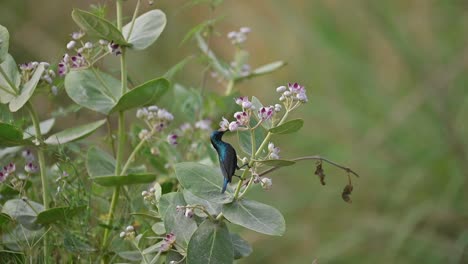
[26, 102, 50, 263]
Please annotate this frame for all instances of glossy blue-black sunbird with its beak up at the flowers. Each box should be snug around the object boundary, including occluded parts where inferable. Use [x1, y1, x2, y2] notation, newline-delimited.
[210, 130, 239, 193]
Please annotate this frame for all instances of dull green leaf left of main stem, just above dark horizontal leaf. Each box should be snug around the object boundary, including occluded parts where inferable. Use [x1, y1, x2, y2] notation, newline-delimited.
[86, 147, 116, 177]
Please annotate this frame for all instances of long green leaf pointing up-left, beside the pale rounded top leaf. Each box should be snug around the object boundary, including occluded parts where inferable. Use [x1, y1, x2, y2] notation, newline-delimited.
[72, 9, 128, 45]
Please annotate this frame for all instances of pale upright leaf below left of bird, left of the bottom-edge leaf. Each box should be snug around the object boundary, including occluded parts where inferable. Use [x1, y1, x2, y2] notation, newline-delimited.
[163, 193, 197, 248]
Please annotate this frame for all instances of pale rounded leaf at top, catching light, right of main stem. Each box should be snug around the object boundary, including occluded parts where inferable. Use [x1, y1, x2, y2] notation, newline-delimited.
[122, 9, 166, 50]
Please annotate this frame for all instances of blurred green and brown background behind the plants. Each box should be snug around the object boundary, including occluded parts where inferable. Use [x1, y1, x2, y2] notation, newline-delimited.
[0, 0, 468, 263]
